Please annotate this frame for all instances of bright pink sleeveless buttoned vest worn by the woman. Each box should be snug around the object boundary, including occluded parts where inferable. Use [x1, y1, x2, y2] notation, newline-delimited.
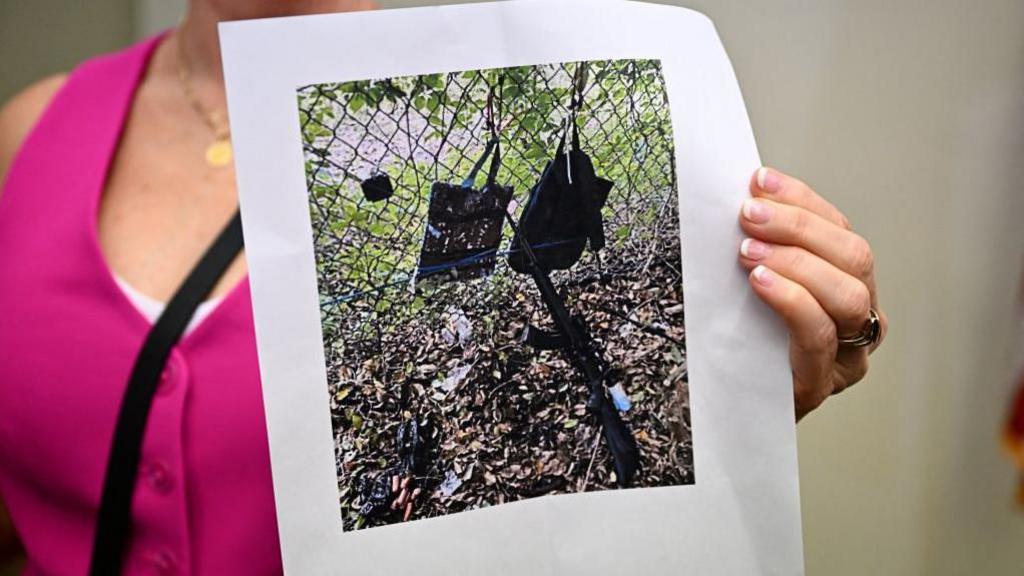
[0, 39, 281, 575]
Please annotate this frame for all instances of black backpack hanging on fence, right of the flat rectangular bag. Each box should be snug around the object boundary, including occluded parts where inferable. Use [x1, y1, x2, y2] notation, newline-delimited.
[509, 71, 614, 274]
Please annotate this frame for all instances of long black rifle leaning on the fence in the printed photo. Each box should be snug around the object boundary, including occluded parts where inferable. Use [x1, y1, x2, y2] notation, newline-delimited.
[497, 204, 640, 488]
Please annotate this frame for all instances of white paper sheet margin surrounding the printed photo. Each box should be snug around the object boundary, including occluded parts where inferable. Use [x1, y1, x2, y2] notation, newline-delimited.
[220, 0, 803, 575]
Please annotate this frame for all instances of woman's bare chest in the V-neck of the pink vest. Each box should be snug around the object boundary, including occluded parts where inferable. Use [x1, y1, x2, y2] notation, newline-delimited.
[96, 73, 246, 301]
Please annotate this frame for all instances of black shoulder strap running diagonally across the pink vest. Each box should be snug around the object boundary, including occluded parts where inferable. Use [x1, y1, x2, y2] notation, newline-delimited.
[89, 208, 243, 576]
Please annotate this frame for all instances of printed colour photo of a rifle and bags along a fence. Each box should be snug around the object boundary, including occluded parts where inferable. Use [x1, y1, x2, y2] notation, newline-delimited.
[297, 59, 695, 531]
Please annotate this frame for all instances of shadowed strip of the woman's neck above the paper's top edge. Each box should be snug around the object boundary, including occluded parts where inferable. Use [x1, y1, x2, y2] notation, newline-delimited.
[175, 0, 377, 89]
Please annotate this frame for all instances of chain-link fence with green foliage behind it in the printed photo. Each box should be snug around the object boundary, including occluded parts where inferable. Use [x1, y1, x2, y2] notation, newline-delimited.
[298, 60, 676, 352]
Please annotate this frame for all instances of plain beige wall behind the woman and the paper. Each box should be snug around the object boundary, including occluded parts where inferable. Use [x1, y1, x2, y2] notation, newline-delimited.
[0, 0, 1024, 576]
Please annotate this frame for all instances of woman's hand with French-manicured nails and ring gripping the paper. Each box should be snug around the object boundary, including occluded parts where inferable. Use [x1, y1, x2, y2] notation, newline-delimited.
[739, 168, 889, 421]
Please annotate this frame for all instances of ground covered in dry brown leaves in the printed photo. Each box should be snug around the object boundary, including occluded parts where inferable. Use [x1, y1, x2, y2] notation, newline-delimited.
[327, 225, 694, 530]
